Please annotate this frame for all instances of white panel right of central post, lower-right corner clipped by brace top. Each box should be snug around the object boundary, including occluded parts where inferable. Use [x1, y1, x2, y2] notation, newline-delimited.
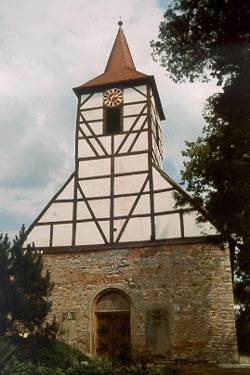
[114, 173, 149, 194]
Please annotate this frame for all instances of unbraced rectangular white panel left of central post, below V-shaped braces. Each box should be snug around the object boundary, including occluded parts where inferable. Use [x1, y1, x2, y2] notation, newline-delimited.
[79, 159, 110, 178]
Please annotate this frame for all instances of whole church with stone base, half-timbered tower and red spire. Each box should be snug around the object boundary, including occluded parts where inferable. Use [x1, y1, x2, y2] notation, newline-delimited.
[27, 21, 237, 363]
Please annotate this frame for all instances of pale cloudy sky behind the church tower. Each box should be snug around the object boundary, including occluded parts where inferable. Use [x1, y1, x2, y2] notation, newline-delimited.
[0, 0, 218, 237]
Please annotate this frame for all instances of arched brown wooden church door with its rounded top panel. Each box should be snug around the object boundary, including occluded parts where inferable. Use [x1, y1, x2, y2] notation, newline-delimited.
[95, 290, 131, 362]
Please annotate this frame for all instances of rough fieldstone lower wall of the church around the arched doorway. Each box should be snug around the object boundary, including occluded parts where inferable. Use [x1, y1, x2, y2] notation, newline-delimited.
[44, 242, 238, 363]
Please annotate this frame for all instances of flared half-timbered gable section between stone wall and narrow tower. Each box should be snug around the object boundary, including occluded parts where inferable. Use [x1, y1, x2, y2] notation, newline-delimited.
[24, 165, 218, 250]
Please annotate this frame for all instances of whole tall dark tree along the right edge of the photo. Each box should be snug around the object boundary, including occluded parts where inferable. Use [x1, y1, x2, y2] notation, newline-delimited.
[151, 0, 250, 349]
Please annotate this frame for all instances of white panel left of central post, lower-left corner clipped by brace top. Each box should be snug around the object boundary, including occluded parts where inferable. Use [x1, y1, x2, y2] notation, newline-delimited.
[77, 178, 110, 198]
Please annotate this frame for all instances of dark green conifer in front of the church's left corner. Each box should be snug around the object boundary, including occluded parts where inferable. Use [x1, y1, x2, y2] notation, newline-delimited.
[0, 227, 53, 336]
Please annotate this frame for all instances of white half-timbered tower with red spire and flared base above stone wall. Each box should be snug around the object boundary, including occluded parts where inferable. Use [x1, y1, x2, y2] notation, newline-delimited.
[25, 21, 215, 252]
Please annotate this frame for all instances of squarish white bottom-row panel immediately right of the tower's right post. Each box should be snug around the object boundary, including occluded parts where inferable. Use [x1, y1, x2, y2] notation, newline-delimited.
[155, 213, 181, 240]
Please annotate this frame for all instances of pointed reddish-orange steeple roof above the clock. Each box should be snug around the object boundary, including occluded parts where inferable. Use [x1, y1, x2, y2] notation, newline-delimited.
[74, 21, 149, 92]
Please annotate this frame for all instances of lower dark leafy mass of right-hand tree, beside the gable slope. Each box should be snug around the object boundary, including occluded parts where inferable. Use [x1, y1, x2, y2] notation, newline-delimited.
[182, 80, 250, 239]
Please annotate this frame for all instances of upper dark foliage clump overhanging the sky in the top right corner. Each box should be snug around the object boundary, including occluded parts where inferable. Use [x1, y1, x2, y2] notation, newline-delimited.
[151, 0, 250, 84]
